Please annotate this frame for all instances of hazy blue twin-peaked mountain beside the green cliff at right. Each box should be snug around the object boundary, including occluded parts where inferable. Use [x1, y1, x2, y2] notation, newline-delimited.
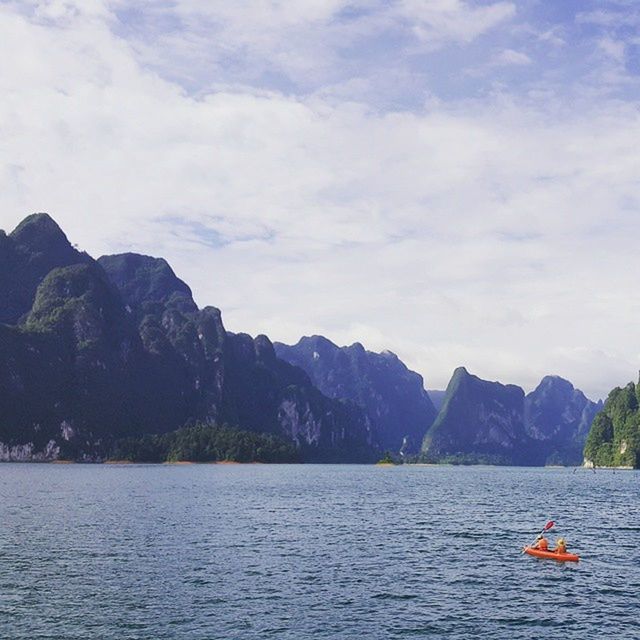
[422, 367, 600, 465]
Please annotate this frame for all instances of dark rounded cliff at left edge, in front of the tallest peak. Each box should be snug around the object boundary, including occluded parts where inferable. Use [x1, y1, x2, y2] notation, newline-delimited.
[0, 263, 163, 459]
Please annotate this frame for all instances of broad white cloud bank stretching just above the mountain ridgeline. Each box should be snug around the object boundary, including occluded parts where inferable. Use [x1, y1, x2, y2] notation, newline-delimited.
[0, 3, 640, 396]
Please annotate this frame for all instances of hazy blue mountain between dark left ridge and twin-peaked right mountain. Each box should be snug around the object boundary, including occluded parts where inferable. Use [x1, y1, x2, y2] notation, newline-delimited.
[275, 336, 436, 453]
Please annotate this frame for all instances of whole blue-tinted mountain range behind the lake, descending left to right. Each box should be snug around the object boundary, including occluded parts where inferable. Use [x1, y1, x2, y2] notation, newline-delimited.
[0, 214, 600, 464]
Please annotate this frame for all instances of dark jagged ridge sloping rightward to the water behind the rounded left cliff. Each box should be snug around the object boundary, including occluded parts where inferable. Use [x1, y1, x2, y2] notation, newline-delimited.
[99, 254, 376, 461]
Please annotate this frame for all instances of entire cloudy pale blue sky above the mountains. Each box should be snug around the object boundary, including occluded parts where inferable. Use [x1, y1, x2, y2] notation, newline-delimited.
[0, 0, 640, 399]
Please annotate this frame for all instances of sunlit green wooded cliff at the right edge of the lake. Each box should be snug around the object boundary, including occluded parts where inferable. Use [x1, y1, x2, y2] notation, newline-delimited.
[584, 382, 640, 469]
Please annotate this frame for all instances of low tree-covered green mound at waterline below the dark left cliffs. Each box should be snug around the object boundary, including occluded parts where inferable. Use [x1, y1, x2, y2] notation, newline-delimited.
[109, 423, 300, 463]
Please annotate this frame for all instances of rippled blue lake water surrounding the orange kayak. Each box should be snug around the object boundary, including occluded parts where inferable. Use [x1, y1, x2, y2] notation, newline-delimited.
[0, 464, 640, 640]
